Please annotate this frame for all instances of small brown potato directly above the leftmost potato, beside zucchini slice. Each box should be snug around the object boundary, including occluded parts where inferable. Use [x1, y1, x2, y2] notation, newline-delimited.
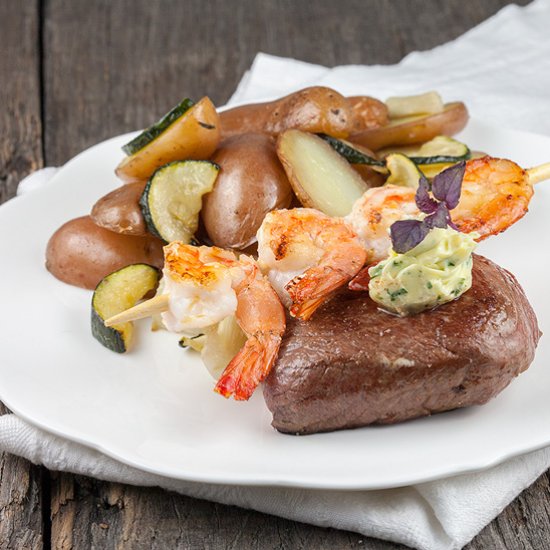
[90, 181, 147, 236]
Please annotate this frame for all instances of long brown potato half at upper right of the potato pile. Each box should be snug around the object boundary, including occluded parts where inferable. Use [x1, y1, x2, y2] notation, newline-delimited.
[350, 102, 468, 151]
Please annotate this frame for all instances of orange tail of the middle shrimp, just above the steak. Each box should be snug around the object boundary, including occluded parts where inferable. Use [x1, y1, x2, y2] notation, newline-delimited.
[285, 267, 351, 321]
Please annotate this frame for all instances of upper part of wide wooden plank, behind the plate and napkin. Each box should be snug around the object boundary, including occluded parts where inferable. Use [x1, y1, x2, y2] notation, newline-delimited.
[40, 0, 526, 164]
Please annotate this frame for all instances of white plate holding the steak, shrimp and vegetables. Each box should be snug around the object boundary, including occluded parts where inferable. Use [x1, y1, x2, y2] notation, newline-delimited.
[0, 121, 550, 489]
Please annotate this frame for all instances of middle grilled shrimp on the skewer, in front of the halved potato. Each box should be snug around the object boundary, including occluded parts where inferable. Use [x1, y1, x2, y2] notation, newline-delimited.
[258, 208, 367, 321]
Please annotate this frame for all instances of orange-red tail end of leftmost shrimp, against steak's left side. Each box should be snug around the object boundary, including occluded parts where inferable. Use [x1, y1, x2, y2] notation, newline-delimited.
[214, 334, 281, 401]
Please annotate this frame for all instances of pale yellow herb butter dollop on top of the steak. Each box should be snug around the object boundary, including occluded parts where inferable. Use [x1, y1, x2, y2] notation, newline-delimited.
[369, 227, 478, 316]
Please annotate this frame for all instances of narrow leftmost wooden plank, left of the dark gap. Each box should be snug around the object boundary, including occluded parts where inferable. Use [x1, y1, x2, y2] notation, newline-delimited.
[0, 0, 44, 549]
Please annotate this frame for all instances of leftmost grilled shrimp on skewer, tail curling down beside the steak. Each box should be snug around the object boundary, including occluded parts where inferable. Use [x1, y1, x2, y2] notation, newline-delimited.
[162, 242, 286, 400]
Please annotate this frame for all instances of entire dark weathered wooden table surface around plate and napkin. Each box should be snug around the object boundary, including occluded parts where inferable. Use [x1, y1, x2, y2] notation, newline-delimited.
[0, 0, 550, 550]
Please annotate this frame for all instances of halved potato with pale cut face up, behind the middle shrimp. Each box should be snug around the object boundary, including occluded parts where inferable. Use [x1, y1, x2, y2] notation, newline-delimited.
[277, 130, 368, 216]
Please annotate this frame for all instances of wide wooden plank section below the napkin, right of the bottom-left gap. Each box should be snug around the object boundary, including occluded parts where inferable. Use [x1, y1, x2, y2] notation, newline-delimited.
[52, 474, 404, 550]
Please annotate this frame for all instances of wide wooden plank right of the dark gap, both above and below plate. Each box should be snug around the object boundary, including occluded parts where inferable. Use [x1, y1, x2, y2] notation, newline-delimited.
[44, 0, 550, 550]
